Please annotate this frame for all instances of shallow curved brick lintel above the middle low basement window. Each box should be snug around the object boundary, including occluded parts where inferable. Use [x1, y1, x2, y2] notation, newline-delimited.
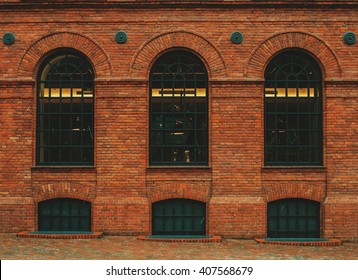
[148, 186, 210, 203]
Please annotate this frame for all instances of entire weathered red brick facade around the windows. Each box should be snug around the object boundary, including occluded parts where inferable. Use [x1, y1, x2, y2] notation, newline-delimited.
[0, 0, 358, 240]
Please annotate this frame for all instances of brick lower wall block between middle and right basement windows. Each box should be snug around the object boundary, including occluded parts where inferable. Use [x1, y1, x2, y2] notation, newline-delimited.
[208, 196, 266, 238]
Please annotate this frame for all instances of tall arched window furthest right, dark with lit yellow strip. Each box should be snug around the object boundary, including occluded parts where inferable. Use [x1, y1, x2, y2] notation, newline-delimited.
[265, 51, 323, 165]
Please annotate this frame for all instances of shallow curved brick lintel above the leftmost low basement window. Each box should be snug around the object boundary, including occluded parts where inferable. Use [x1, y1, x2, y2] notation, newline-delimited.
[34, 181, 96, 203]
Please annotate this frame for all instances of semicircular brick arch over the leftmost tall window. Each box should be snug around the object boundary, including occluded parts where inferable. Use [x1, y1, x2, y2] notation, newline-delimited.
[17, 32, 112, 79]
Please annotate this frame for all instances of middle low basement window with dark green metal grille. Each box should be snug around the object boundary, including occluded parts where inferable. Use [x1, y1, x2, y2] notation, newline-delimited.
[152, 199, 206, 236]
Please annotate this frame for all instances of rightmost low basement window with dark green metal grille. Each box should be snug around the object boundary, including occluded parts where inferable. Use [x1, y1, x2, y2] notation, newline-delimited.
[267, 199, 320, 238]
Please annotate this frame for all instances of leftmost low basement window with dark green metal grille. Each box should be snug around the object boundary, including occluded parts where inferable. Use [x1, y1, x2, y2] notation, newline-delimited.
[38, 198, 91, 232]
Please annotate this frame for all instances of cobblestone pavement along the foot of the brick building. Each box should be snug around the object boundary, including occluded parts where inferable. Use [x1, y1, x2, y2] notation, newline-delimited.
[0, 234, 358, 260]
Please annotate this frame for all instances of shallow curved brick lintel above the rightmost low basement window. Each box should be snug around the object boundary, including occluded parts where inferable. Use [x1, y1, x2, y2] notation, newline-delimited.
[263, 182, 326, 202]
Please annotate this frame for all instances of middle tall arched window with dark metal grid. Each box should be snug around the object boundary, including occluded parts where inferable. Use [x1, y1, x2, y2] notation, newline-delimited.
[149, 51, 208, 165]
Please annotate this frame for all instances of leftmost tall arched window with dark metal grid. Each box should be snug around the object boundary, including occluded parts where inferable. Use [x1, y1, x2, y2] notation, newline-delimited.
[37, 51, 94, 165]
